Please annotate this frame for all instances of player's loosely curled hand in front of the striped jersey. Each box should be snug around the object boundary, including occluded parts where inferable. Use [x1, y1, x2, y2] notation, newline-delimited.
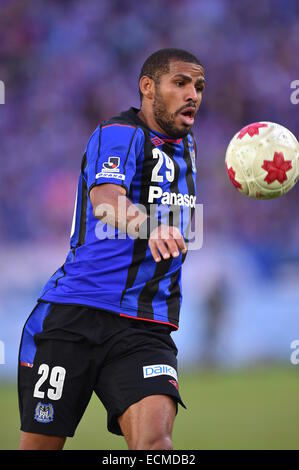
[148, 224, 187, 263]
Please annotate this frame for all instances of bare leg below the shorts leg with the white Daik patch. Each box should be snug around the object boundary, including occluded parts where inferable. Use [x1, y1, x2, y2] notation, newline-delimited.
[118, 395, 177, 450]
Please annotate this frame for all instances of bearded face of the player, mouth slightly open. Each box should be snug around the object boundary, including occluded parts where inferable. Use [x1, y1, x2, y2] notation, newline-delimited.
[153, 61, 205, 138]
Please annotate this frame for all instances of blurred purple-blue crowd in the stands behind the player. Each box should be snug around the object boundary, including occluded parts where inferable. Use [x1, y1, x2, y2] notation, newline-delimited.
[0, 0, 299, 271]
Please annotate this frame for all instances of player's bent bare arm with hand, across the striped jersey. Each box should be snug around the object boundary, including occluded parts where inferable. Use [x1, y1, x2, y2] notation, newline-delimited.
[90, 183, 187, 262]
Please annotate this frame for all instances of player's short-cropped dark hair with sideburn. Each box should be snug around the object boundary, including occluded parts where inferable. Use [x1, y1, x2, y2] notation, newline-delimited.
[138, 48, 203, 101]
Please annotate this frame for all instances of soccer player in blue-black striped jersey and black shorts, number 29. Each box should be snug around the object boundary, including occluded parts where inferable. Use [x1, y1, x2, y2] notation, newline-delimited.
[18, 49, 205, 450]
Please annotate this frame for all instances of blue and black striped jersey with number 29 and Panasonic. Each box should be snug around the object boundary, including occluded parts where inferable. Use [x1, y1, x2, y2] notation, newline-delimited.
[39, 108, 196, 329]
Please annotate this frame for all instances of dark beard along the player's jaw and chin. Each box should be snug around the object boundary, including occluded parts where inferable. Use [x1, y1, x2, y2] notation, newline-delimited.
[153, 87, 190, 139]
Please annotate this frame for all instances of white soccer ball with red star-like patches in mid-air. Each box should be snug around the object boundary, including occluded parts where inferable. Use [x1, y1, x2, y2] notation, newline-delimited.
[225, 121, 299, 199]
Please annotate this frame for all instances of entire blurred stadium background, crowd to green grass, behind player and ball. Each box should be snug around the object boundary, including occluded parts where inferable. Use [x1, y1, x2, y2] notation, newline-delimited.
[0, 0, 299, 449]
